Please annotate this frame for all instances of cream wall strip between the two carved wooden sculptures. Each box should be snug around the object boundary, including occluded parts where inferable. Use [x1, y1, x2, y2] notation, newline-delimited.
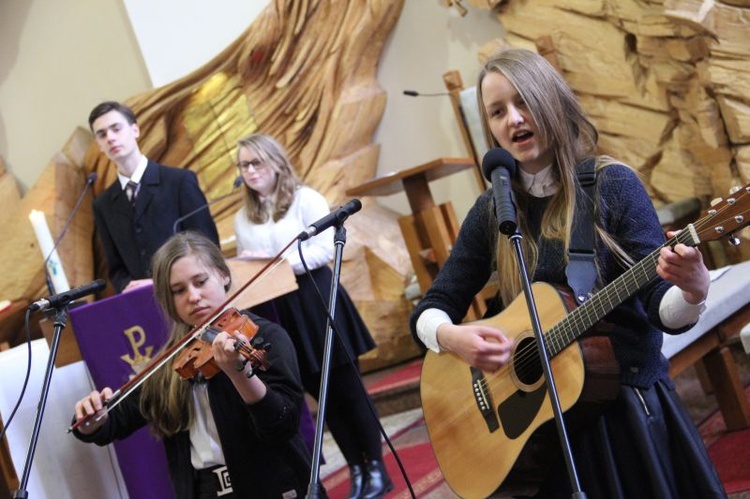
[373, 0, 502, 219]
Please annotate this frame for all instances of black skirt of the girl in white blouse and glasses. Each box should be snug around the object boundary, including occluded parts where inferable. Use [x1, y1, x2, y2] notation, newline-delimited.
[274, 267, 375, 376]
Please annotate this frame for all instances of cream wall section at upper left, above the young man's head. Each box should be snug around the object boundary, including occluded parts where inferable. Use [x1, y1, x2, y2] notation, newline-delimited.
[0, 0, 150, 192]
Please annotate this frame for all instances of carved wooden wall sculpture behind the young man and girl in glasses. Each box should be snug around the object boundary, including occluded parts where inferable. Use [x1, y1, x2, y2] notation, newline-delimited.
[0, 0, 418, 369]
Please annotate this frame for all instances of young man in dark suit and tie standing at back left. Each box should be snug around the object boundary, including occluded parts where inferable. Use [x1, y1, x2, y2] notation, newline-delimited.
[89, 101, 219, 293]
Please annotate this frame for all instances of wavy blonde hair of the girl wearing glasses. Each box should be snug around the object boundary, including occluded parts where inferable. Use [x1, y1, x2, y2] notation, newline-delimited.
[237, 133, 300, 224]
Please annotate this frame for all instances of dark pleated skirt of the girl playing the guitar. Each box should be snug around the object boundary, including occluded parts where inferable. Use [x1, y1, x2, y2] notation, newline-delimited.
[537, 382, 726, 499]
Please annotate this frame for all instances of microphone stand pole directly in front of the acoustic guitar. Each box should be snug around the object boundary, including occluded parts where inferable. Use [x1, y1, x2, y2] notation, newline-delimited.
[501, 229, 586, 499]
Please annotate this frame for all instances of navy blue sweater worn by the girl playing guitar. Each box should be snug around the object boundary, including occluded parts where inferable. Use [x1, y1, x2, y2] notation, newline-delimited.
[410, 164, 689, 388]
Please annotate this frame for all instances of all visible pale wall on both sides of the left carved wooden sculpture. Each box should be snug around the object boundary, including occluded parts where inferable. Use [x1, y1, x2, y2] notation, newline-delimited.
[0, 0, 501, 218]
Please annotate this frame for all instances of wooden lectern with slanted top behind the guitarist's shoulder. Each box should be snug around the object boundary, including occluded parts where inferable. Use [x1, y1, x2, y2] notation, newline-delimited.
[346, 158, 494, 320]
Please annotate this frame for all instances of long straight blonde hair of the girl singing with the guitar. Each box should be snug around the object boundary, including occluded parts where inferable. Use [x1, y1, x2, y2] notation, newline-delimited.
[477, 49, 630, 304]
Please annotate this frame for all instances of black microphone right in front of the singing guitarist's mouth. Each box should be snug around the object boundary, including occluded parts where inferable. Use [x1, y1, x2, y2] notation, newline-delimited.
[482, 147, 518, 236]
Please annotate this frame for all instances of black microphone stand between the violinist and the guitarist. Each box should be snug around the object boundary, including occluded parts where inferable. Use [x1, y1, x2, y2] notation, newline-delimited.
[306, 220, 346, 499]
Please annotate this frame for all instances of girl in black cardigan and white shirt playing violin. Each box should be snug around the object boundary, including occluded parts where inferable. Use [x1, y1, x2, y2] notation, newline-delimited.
[74, 232, 318, 499]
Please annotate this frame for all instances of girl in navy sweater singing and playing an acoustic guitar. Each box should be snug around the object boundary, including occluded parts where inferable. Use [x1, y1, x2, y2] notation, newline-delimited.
[411, 49, 725, 499]
